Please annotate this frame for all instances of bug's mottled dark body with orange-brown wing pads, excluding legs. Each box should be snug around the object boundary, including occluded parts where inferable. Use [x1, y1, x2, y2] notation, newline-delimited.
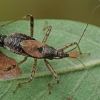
[2, 33, 69, 59]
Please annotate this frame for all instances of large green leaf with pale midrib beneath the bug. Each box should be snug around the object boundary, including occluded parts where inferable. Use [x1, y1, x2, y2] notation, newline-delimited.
[0, 20, 100, 100]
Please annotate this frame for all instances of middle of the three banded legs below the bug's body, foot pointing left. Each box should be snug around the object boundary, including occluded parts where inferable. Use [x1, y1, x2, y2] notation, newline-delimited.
[13, 59, 37, 93]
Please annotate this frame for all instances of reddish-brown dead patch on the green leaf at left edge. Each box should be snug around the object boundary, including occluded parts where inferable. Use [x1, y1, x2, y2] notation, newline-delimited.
[0, 52, 21, 78]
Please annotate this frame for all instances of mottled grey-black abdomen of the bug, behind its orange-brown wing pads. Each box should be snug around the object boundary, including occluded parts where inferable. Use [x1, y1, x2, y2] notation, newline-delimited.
[4, 33, 35, 56]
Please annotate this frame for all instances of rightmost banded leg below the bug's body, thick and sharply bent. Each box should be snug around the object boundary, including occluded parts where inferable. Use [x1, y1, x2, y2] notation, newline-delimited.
[44, 59, 59, 93]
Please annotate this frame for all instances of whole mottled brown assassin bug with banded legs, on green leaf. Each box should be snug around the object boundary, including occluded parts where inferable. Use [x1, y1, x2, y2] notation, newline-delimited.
[0, 14, 88, 93]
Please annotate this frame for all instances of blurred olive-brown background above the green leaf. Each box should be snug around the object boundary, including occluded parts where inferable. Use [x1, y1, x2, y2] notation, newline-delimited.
[0, 0, 100, 26]
